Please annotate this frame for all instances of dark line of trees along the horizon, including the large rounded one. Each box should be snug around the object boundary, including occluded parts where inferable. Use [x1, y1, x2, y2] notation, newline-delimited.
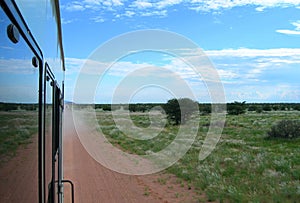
[95, 98, 300, 125]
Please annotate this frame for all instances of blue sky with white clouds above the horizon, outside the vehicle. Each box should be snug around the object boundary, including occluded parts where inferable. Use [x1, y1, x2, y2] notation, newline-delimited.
[60, 0, 300, 103]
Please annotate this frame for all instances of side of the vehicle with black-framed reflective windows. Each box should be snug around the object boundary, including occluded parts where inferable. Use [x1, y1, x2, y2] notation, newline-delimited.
[0, 0, 72, 202]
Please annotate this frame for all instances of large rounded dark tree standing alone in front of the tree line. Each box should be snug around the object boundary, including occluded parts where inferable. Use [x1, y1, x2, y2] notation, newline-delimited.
[164, 98, 198, 125]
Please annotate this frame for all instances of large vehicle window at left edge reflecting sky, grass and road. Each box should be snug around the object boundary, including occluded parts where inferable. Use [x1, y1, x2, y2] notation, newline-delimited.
[0, 5, 40, 202]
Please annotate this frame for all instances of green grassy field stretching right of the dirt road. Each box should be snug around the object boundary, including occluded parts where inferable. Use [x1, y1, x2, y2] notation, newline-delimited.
[97, 111, 300, 202]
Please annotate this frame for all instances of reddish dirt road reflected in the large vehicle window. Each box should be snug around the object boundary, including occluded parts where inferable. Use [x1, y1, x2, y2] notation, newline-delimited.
[0, 136, 38, 203]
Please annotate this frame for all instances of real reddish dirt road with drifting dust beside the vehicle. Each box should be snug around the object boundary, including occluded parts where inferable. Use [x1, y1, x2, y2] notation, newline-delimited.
[63, 110, 199, 203]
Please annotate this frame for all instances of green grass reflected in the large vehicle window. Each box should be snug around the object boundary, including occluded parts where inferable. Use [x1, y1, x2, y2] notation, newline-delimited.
[0, 111, 37, 162]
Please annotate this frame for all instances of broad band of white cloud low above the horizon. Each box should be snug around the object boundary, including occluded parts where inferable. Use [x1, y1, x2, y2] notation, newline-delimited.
[66, 45, 300, 102]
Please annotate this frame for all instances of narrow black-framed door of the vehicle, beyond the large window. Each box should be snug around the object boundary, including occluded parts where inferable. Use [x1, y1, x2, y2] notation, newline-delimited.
[44, 64, 63, 202]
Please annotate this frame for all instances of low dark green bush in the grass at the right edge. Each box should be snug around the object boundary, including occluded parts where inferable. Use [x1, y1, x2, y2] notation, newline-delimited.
[268, 120, 300, 139]
